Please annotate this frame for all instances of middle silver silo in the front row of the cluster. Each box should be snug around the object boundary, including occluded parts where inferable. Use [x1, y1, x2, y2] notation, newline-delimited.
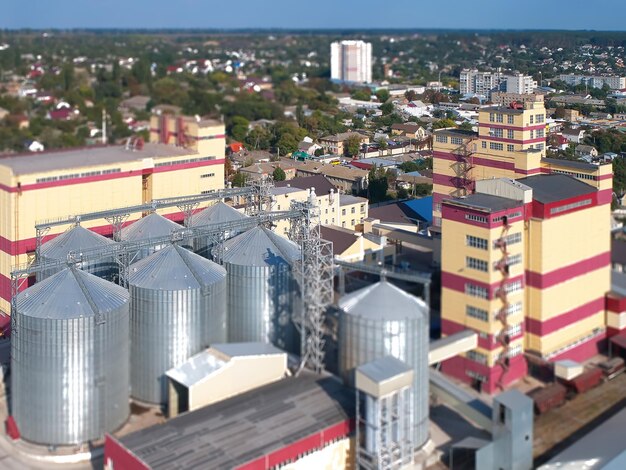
[129, 245, 227, 404]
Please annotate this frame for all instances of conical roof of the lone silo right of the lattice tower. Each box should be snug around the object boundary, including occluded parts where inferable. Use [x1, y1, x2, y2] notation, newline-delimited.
[339, 281, 428, 320]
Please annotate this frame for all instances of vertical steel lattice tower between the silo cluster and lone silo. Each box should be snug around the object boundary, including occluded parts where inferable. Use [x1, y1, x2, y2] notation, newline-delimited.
[290, 201, 334, 373]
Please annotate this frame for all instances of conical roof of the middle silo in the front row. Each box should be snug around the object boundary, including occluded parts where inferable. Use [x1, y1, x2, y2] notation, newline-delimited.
[129, 245, 226, 290]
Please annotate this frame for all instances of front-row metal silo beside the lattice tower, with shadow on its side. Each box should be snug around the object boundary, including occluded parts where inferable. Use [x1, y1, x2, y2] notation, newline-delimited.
[222, 227, 300, 352]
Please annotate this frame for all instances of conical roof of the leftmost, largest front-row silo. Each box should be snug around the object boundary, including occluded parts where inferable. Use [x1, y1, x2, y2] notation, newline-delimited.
[17, 268, 129, 319]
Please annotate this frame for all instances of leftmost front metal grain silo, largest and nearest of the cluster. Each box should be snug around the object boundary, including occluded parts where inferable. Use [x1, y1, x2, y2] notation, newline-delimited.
[11, 267, 130, 445]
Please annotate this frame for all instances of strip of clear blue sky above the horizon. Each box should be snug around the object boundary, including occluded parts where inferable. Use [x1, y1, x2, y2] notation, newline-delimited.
[0, 0, 626, 31]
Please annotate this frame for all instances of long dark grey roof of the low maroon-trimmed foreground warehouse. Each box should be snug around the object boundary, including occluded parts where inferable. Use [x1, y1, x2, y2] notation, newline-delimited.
[119, 372, 354, 470]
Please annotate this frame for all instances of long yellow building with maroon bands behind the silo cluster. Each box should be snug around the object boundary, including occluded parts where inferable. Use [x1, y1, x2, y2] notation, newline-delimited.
[0, 115, 225, 312]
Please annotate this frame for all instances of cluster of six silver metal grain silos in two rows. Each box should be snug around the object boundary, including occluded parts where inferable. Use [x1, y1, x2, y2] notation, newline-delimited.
[11, 203, 299, 445]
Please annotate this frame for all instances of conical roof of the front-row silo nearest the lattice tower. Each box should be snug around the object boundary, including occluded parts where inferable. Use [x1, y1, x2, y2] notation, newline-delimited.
[223, 227, 300, 267]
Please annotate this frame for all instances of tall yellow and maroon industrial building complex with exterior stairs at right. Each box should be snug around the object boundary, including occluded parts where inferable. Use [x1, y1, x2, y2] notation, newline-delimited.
[433, 101, 616, 393]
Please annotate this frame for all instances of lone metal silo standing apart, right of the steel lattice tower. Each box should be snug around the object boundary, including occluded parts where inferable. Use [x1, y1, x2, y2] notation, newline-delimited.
[339, 281, 429, 448]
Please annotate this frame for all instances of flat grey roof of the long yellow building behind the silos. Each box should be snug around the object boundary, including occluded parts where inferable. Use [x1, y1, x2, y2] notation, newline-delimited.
[0, 143, 196, 175]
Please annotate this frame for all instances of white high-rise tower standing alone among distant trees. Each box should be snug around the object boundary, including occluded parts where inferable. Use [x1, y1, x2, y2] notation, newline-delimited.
[330, 41, 372, 83]
